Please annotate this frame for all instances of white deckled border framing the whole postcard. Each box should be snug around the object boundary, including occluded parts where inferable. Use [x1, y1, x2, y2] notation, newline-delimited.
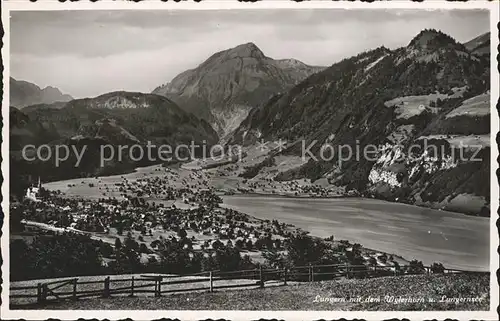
[0, 0, 500, 320]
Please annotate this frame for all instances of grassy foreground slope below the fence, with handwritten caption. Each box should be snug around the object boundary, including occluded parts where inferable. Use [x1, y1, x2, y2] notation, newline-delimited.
[40, 274, 490, 311]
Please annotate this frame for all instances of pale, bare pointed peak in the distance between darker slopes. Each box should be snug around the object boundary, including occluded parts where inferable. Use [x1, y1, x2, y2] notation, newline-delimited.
[153, 43, 324, 138]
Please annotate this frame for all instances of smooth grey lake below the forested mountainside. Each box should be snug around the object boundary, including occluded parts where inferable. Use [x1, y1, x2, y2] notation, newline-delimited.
[223, 195, 490, 271]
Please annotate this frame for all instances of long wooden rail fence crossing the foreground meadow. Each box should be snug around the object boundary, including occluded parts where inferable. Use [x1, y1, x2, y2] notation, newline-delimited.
[10, 264, 488, 306]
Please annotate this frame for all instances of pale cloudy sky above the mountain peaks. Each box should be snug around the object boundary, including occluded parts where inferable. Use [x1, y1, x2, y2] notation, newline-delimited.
[10, 9, 489, 98]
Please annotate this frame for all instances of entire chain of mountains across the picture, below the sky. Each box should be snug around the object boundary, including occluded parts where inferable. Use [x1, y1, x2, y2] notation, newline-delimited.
[11, 29, 490, 215]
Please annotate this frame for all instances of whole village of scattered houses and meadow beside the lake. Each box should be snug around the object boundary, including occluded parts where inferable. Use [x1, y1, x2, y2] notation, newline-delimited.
[11, 162, 408, 278]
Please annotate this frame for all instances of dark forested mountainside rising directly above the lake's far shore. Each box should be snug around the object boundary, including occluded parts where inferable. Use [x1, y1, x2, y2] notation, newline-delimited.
[229, 30, 490, 213]
